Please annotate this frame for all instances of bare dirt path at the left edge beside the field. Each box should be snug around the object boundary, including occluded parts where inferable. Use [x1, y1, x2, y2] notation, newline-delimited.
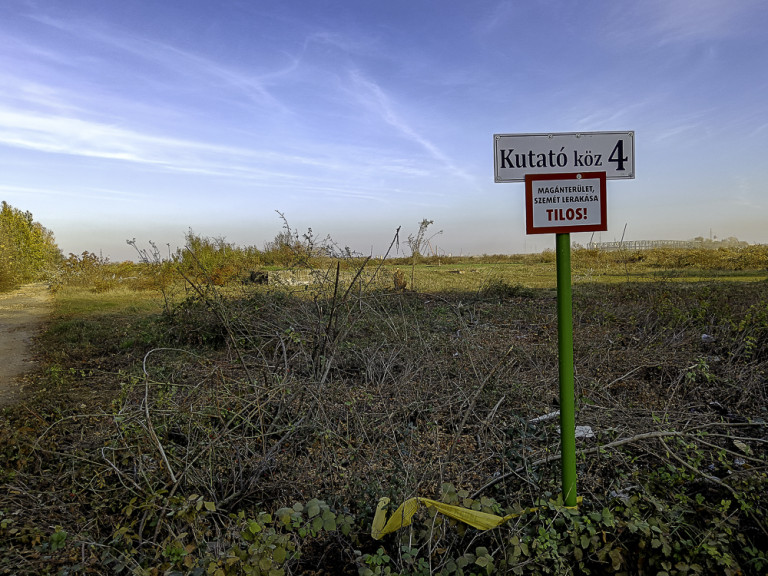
[0, 284, 53, 406]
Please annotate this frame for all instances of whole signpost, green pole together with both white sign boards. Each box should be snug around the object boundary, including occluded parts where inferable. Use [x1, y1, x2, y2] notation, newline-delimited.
[493, 130, 635, 506]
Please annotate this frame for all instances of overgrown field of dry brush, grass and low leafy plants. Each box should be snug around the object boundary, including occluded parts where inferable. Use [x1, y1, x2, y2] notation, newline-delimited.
[0, 227, 768, 576]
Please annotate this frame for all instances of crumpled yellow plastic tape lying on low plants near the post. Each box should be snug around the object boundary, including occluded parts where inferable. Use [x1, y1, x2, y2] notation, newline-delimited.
[371, 496, 581, 540]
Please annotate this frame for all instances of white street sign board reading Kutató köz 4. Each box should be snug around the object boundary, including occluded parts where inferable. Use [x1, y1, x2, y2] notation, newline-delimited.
[493, 131, 635, 182]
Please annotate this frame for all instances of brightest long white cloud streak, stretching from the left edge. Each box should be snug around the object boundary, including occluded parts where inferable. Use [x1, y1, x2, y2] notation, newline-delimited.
[0, 99, 438, 196]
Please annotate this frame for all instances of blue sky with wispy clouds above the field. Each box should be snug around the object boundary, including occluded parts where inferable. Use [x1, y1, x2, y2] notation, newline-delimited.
[0, 0, 768, 260]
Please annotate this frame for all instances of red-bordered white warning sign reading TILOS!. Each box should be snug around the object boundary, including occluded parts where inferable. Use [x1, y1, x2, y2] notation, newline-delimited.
[525, 172, 608, 234]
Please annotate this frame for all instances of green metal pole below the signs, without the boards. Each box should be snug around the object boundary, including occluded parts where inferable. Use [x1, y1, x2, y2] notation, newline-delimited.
[556, 233, 576, 506]
